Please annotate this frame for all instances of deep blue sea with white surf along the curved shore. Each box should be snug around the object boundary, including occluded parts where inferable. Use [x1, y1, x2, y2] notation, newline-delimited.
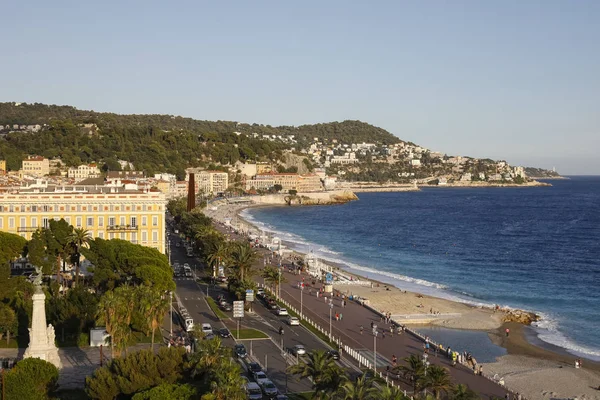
[242, 176, 600, 361]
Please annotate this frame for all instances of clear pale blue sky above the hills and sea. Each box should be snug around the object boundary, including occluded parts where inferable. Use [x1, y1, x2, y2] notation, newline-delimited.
[0, 0, 600, 174]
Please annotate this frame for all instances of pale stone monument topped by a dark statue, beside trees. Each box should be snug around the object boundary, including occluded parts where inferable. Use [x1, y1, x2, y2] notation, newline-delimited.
[23, 267, 62, 369]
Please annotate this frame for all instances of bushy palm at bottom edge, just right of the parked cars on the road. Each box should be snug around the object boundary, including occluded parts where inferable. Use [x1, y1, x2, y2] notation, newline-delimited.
[288, 350, 346, 399]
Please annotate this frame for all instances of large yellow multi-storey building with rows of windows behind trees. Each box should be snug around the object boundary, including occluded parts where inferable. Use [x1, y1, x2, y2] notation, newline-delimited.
[0, 186, 166, 253]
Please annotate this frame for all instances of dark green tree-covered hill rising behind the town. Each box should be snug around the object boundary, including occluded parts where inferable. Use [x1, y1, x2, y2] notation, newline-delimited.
[0, 103, 400, 177]
